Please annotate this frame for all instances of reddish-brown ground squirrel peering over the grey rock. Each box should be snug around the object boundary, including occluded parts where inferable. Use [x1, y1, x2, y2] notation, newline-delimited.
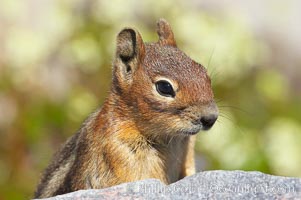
[35, 19, 219, 198]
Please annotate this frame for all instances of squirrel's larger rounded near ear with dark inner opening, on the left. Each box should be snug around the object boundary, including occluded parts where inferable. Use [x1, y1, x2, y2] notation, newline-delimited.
[116, 28, 145, 73]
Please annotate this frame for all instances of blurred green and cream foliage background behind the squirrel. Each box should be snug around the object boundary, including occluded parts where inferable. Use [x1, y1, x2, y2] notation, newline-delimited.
[0, 0, 301, 200]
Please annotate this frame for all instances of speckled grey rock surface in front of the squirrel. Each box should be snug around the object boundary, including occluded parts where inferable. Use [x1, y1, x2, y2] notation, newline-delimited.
[38, 171, 301, 200]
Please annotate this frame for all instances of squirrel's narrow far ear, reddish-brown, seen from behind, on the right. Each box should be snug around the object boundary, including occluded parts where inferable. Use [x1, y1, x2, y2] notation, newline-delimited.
[157, 19, 177, 47]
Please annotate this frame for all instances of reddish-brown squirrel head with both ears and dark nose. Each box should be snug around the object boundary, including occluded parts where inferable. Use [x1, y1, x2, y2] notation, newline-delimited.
[112, 19, 218, 137]
